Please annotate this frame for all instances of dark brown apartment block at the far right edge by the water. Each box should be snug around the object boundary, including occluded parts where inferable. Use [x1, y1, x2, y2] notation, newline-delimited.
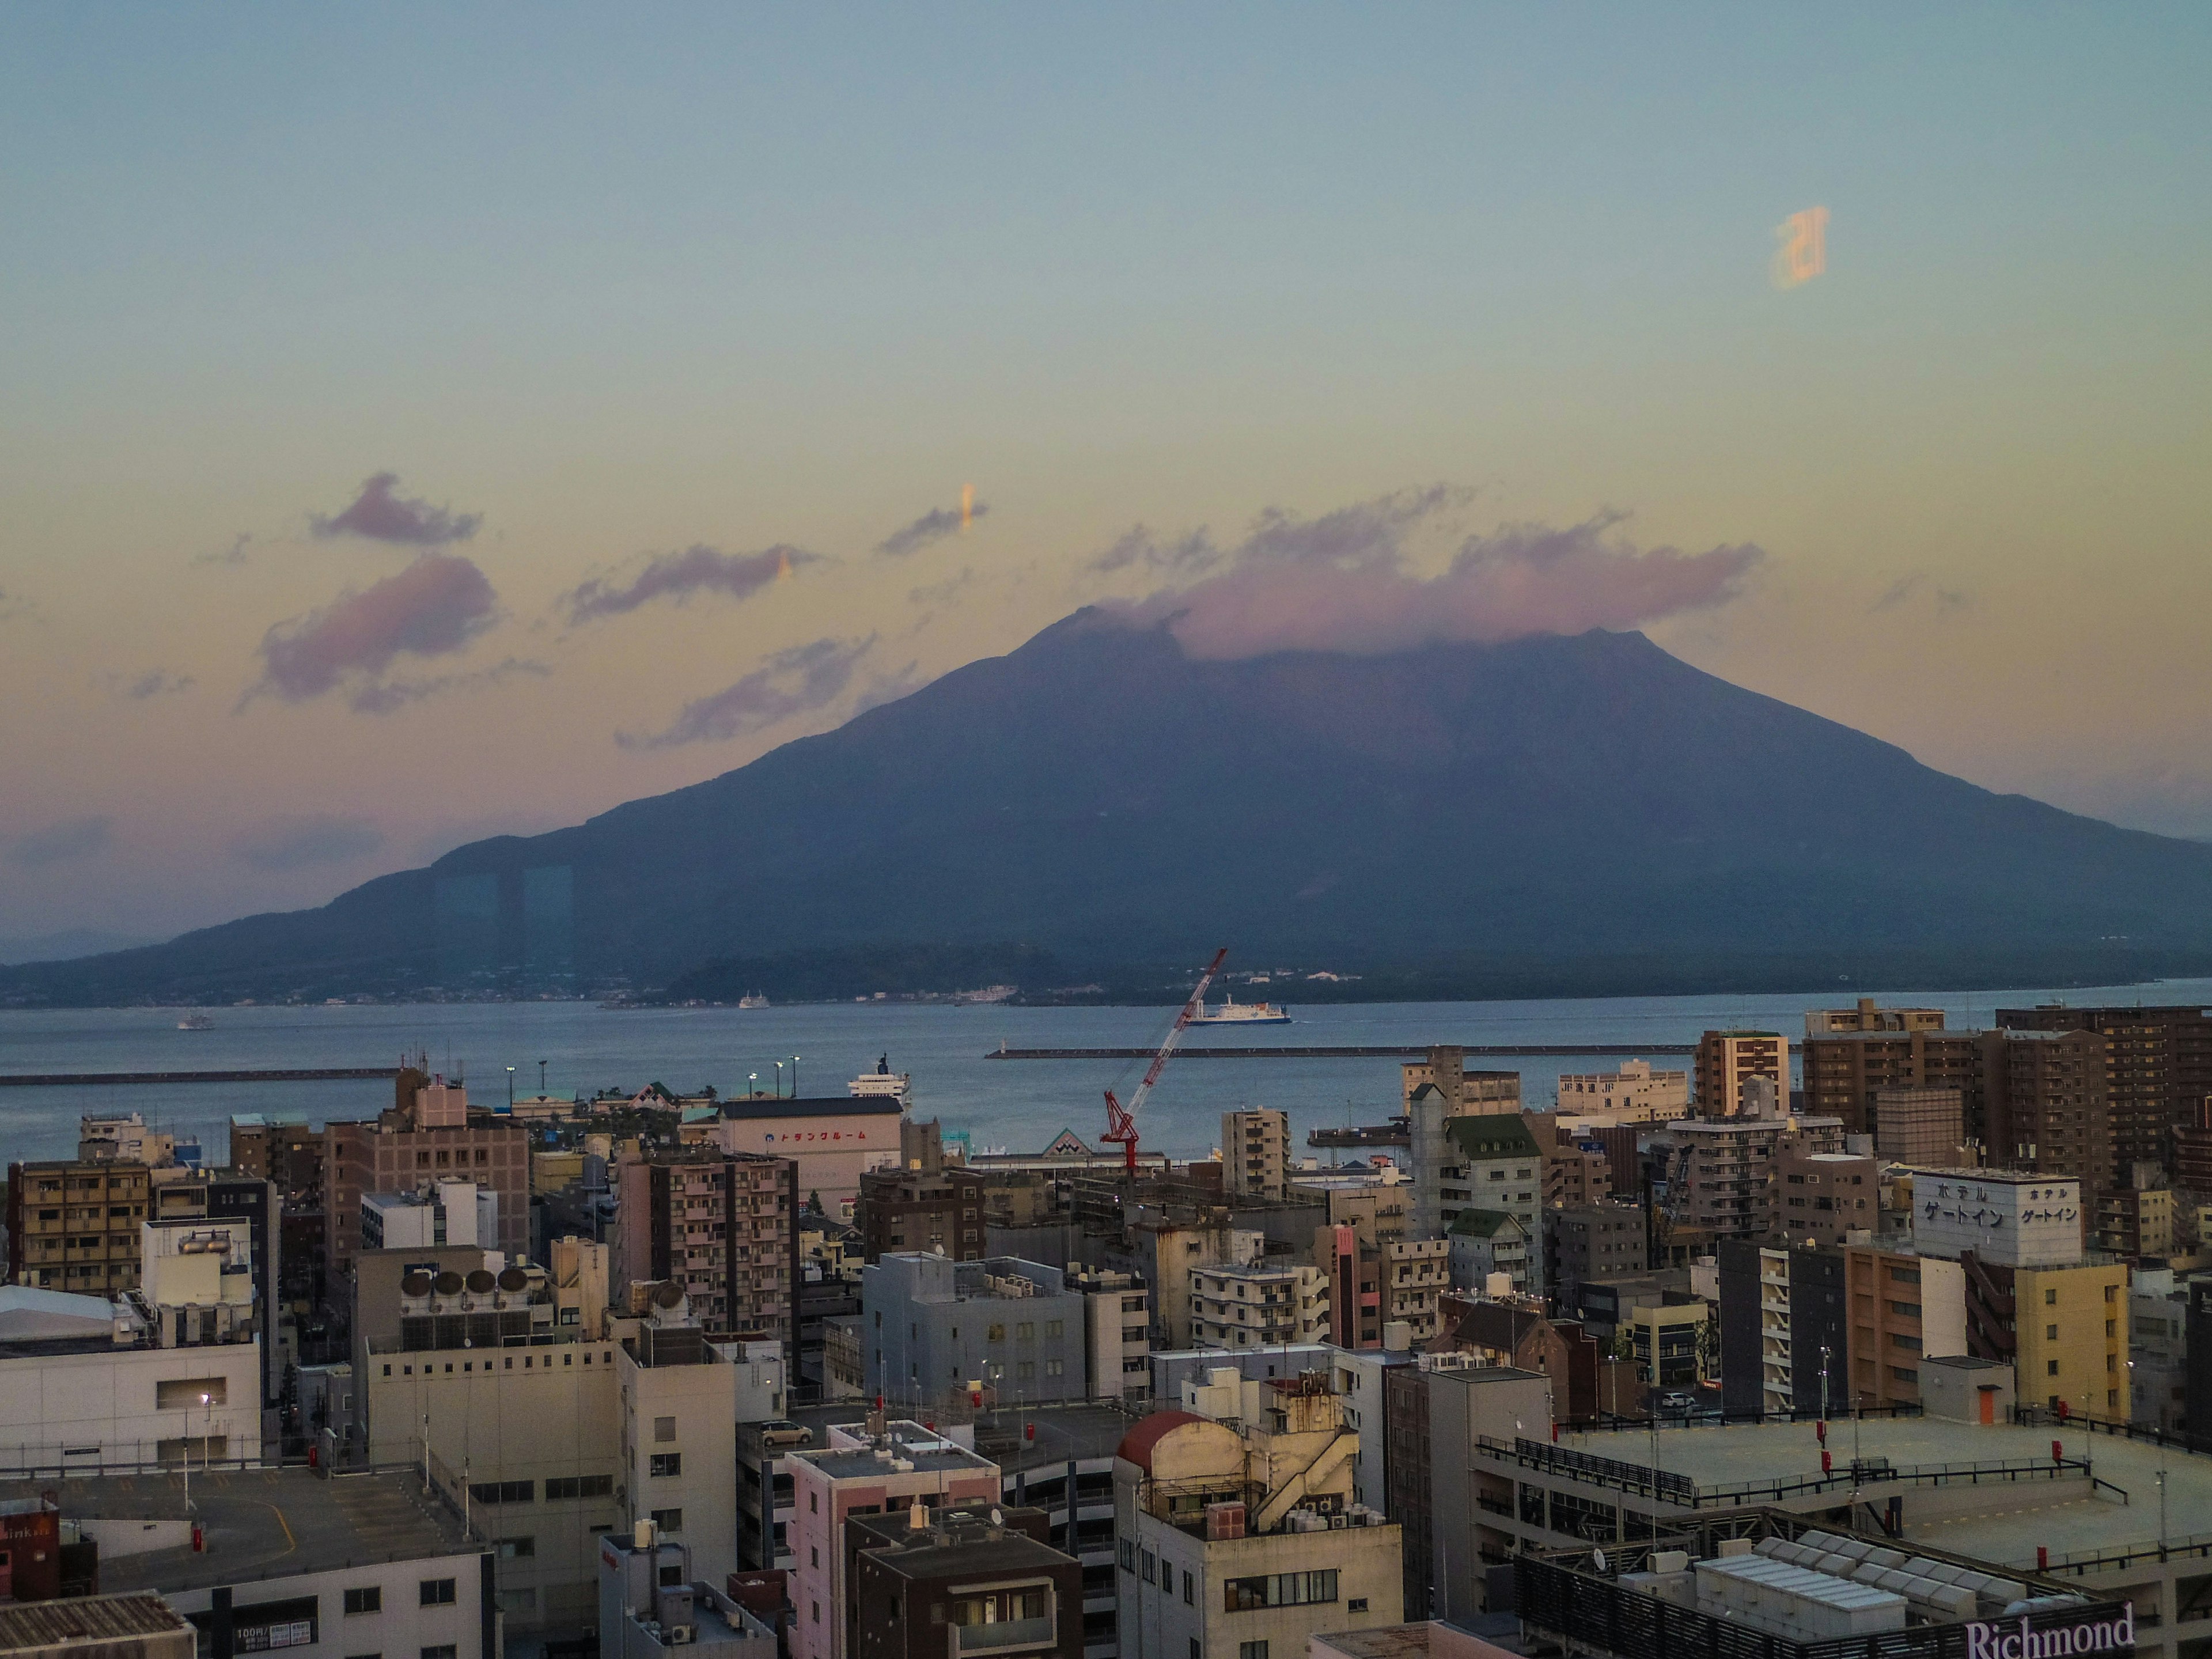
[1998, 1004, 2212, 1194]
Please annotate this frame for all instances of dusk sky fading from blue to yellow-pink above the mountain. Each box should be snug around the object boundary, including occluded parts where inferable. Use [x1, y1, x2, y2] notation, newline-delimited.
[0, 5, 2212, 938]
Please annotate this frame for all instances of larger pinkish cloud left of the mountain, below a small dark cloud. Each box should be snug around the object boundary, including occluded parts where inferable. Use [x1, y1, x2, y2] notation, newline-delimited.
[241, 553, 500, 706]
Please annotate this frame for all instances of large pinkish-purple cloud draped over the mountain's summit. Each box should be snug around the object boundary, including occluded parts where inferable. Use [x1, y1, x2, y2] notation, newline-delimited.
[1115, 489, 1765, 659]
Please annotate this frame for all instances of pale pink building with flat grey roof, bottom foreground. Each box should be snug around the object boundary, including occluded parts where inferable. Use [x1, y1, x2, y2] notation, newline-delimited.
[781, 1416, 1002, 1659]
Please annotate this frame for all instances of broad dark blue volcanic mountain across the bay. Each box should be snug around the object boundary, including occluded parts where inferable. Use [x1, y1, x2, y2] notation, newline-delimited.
[0, 611, 2212, 1000]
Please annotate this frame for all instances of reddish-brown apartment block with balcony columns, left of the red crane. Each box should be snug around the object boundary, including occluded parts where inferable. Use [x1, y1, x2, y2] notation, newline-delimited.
[610, 1146, 798, 1365]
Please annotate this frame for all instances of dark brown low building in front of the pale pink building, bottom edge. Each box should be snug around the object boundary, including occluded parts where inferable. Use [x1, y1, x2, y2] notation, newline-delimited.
[843, 1504, 1084, 1659]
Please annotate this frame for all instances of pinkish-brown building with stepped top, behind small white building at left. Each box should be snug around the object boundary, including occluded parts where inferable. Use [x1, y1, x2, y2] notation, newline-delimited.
[323, 1071, 531, 1285]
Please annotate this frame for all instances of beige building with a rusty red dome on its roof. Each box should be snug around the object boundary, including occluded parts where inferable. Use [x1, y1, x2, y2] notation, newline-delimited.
[1113, 1376, 1404, 1659]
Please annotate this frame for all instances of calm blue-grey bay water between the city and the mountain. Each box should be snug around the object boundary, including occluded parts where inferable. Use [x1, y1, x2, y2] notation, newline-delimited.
[0, 980, 2212, 1161]
